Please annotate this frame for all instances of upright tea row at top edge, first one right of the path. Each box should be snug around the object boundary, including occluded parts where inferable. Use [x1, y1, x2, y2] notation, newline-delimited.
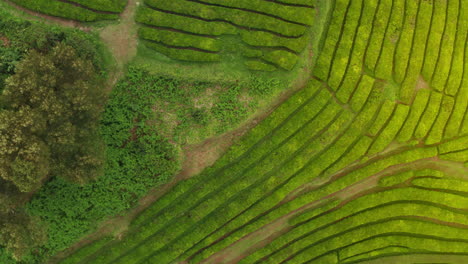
[313, 0, 350, 81]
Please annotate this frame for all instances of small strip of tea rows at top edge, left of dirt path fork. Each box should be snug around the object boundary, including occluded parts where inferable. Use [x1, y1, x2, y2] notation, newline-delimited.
[11, 0, 127, 22]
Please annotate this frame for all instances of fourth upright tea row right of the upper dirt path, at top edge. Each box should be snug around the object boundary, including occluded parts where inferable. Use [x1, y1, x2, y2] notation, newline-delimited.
[364, 0, 398, 75]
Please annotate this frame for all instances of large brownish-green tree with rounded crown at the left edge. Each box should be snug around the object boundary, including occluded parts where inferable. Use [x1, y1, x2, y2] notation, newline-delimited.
[0, 43, 104, 258]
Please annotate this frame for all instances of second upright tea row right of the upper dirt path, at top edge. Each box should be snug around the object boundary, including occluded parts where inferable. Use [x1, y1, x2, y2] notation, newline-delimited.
[328, 1, 363, 90]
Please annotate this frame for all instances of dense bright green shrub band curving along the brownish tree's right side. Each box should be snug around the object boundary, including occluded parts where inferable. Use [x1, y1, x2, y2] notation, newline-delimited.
[28, 67, 178, 260]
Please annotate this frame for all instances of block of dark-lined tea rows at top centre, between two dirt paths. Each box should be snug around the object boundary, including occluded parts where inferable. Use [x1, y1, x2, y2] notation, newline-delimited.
[137, 0, 314, 71]
